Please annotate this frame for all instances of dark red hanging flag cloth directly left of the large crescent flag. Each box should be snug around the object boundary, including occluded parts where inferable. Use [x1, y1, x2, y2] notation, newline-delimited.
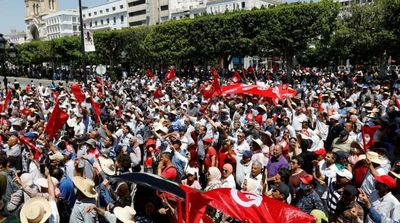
[179, 184, 209, 223]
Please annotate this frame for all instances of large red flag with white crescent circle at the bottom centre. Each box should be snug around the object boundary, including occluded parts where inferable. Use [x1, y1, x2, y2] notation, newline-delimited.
[203, 188, 315, 223]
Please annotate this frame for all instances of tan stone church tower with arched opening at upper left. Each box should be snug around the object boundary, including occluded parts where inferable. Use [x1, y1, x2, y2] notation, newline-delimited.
[25, 0, 58, 41]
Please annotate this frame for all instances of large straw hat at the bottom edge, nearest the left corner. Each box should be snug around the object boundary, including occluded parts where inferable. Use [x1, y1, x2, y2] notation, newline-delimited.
[19, 197, 51, 223]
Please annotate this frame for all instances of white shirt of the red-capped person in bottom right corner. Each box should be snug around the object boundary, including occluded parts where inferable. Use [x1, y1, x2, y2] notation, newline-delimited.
[368, 190, 400, 222]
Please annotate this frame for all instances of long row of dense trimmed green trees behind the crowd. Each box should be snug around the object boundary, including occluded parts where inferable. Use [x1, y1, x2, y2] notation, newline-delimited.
[11, 0, 400, 73]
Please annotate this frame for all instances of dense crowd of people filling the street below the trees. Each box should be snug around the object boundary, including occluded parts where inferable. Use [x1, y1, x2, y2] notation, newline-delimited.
[0, 67, 400, 223]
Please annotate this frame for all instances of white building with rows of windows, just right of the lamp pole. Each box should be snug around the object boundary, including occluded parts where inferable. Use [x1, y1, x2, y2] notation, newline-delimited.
[82, 0, 128, 30]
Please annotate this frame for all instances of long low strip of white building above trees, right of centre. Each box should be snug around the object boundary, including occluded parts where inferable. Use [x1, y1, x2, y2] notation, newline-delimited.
[207, 0, 282, 14]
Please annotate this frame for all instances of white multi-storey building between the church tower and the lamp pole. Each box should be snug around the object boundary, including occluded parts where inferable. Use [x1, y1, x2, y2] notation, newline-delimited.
[43, 9, 80, 40]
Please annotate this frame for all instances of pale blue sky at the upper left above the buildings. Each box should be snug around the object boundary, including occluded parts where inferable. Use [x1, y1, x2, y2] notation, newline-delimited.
[0, 0, 107, 34]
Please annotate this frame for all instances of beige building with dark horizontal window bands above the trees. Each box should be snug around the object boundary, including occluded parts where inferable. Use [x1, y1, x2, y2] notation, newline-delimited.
[128, 0, 171, 26]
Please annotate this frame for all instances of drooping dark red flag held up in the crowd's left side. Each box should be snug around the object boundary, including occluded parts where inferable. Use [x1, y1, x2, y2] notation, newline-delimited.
[45, 99, 68, 140]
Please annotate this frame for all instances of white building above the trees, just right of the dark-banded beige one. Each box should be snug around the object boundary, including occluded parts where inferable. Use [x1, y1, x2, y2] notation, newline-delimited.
[170, 0, 207, 19]
